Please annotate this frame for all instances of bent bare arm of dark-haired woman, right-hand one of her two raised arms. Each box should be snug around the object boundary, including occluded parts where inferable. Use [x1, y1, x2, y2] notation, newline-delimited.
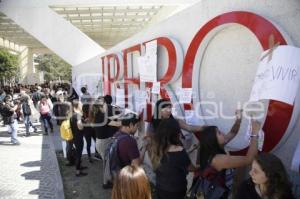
[212, 121, 261, 171]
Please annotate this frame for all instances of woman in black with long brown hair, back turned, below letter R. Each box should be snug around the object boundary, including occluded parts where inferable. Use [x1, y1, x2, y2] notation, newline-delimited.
[149, 118, 197, 199]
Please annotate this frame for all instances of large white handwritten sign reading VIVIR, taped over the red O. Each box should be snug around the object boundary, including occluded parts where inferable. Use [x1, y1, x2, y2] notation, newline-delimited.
[249, 46, 300, 105]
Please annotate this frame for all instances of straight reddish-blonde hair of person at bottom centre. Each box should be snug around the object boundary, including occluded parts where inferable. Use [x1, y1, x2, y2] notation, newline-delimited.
[111, 165, 152, 199]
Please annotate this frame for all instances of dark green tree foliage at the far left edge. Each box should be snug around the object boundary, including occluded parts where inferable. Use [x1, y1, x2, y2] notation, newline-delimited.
[0, 48, 19, 79]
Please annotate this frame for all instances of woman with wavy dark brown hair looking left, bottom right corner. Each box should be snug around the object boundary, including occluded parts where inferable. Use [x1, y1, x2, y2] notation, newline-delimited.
[236, 153, 295, 199]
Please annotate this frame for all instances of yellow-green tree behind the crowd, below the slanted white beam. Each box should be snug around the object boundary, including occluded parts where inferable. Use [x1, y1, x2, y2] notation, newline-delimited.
[34, 54, 72, 81]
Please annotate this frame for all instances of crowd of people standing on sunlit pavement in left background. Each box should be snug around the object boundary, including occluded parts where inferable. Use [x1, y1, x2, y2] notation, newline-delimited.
[0, 84, 72, 145]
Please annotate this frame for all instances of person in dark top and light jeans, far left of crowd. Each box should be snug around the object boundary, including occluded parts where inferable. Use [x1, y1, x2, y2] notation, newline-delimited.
[2, 95, 20, 145]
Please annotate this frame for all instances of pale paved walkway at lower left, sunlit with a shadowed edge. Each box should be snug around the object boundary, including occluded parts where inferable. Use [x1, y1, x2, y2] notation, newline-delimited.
[0, 121, 64, 199]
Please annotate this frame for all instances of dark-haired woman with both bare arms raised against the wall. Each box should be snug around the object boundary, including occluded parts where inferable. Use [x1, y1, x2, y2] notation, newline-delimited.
[199, 114, 261, 199]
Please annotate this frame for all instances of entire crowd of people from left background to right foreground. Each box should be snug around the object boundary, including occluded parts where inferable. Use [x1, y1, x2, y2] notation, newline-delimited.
[1, 83, 294, 199]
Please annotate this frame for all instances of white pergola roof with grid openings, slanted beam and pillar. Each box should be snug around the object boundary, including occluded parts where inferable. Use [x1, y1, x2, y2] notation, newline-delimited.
[0, 0, 199, 83]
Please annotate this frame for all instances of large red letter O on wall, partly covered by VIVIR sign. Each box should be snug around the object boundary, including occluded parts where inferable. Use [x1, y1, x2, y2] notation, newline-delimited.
[182, 12, 293, 153]
